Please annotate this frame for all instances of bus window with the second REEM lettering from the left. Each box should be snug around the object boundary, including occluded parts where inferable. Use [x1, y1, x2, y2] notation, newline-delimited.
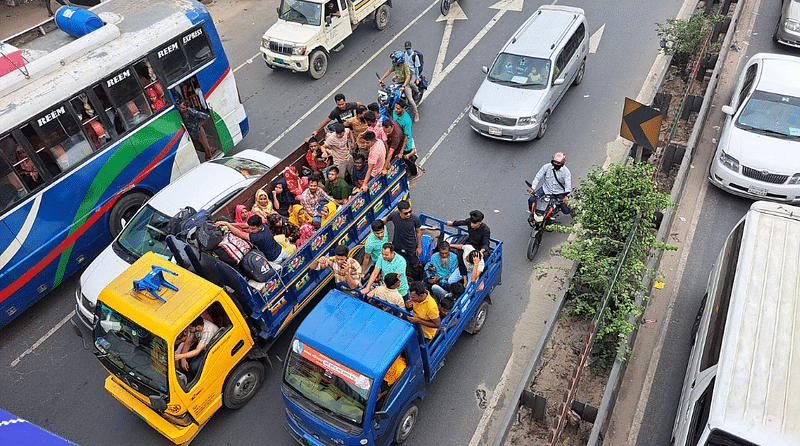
[101, 67, 152, 130]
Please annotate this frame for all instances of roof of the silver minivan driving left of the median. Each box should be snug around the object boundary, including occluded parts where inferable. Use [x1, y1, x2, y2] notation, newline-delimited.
[503, 5, 584, 57]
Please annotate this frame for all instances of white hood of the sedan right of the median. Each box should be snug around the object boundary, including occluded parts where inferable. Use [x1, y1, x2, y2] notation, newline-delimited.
[720, 123, 800, 176]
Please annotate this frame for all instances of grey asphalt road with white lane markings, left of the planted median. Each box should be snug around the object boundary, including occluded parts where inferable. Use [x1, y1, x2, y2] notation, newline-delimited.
[0, 0, 688, 446]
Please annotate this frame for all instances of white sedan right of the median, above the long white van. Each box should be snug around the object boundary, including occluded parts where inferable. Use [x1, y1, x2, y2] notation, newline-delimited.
[708, 53, 800, 203]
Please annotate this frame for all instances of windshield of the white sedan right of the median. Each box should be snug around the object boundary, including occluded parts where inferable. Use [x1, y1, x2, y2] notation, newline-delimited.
[736, 90, 800, 139]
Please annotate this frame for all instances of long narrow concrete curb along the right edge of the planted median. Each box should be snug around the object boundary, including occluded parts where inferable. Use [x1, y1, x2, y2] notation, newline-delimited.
[587, 0, 745, 446]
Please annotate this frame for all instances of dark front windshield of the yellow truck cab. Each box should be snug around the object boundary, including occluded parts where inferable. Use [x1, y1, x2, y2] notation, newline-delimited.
[94, 302, 168, 393]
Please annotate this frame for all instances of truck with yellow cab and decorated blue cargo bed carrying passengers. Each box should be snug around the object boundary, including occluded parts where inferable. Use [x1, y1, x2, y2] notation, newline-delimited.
[82, 153, 408, 444]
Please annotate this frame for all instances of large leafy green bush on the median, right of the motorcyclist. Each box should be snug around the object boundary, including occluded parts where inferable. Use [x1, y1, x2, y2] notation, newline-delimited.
[561, 163, 675, 368]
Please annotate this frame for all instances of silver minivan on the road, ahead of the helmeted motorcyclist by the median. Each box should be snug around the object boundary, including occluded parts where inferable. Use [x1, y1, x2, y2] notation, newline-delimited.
[469, 5, 589, 141]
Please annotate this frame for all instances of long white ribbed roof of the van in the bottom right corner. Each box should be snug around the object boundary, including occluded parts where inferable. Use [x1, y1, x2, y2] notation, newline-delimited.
[708, 202, 800, 445]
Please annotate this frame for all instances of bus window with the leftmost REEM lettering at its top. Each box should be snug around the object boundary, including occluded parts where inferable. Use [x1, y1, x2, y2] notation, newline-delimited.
[31, 104, 94, 176]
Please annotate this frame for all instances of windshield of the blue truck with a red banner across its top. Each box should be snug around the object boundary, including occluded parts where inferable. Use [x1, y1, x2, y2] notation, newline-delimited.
[283, 339, 374, 426]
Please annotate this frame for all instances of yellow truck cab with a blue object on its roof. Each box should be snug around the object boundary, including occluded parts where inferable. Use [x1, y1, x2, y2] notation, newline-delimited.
[93, 253, 264, 444]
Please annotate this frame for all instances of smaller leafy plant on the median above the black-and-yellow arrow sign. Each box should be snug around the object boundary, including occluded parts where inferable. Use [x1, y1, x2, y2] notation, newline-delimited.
[656, 10, 724, 81]
